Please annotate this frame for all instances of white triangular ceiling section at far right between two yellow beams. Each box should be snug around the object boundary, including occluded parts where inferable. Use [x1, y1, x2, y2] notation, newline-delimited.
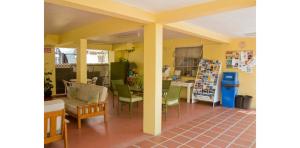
[185, 7, 256, 37]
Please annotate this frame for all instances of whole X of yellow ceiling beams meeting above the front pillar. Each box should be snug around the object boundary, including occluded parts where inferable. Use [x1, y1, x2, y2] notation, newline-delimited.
[45, 0, 248, 43]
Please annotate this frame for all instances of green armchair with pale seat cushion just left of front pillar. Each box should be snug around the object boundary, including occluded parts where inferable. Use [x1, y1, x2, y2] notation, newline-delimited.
[117, 85, 143, 117]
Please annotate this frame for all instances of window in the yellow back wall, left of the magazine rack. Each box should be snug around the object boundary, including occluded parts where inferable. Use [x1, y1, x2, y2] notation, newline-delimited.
[175, 46, 203, 77]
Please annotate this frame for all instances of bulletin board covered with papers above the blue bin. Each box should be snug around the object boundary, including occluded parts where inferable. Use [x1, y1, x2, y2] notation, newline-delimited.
[225, 50, 255, 73]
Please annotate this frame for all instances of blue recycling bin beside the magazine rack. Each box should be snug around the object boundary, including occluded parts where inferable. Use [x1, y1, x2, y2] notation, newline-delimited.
[222, 72, 239, 108]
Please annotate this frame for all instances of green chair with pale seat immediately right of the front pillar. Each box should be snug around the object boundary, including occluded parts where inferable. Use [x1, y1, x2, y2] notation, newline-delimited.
[162, 86, 181, 119]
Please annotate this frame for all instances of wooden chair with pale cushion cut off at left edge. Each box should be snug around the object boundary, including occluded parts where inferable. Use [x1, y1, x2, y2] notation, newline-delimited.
[44, 99, 68, 148]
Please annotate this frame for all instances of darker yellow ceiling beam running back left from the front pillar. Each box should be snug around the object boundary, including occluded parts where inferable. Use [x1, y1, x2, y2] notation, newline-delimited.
[60, 18, 143, 44]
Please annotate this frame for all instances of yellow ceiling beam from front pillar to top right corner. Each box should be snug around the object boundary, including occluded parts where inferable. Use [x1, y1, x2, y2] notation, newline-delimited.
[156, 0, 256, 23]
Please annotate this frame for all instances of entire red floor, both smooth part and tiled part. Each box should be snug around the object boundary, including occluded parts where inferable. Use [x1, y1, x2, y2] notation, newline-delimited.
[45, 92, 256, 148]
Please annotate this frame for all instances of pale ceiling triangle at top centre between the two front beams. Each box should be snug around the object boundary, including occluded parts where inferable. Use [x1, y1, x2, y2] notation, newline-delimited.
[114, 0, 214, 13]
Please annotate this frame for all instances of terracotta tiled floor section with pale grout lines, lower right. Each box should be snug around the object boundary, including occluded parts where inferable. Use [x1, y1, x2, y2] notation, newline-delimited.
[130, 107, 256, 148]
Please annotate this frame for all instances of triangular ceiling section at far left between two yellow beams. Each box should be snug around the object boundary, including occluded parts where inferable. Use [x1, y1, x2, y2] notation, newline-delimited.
[44, 3, 108, 34]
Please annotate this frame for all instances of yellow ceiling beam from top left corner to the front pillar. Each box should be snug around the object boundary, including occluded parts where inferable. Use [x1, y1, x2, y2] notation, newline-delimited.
[45, 0, 155, 23]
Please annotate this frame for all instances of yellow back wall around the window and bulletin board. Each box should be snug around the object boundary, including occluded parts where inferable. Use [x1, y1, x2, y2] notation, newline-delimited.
[112, 38, 256, 108]
